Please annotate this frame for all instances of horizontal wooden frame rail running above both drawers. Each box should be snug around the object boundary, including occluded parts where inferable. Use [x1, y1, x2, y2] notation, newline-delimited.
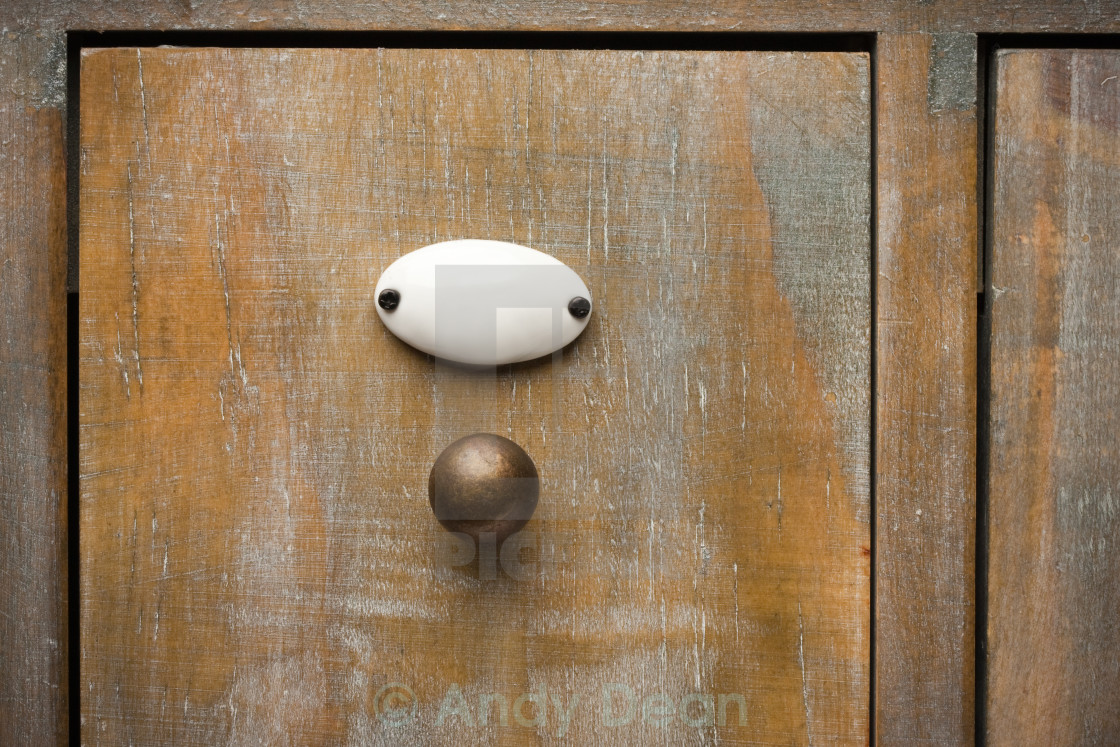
[0, 0, 1120, 34]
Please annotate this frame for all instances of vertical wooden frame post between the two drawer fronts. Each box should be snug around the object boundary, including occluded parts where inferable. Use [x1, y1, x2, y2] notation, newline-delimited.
[875, 35, 977, 745]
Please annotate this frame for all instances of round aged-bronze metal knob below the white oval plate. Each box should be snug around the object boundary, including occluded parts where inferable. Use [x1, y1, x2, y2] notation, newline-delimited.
[428, 433, 541, 544]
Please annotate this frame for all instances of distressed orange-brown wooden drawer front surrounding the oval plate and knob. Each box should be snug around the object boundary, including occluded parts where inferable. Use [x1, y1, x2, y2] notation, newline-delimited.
[81, 49, 870, 744]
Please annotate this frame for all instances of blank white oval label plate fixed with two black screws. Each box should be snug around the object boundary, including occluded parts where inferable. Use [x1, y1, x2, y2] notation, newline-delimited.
[374, 239, 591, 365]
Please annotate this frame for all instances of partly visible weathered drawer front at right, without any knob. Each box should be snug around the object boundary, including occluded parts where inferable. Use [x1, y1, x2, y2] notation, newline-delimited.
[987, 50, 1120, 745]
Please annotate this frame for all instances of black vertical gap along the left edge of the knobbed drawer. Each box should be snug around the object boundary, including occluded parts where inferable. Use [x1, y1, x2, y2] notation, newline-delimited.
[66, 27, 82, 745]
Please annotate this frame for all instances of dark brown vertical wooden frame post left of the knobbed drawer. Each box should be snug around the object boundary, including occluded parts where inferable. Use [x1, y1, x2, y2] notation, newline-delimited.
[0, 30, 67, 745]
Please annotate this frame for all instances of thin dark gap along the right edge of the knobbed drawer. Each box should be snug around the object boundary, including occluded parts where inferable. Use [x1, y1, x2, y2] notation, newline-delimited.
[867, 35, 879, 745]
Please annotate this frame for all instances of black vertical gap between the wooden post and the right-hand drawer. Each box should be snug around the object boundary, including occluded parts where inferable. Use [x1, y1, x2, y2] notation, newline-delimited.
[974, 37, 999, 747]
